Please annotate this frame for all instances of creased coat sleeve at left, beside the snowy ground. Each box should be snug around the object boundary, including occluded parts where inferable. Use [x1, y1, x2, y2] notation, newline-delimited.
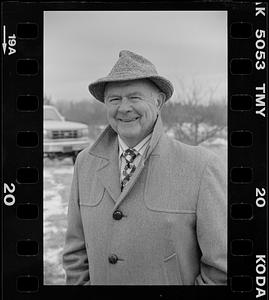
[63, 158, 90, 285]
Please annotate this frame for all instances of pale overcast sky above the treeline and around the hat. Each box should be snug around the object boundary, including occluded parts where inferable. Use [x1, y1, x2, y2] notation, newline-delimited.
[44, 11, 227, 101]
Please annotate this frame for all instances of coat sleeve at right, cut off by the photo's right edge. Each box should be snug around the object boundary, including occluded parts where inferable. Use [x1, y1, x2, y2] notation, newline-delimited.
[195, 154, 228, 285]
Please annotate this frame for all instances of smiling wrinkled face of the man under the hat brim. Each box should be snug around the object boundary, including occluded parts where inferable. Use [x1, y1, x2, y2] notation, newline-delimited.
[104, 79, 165, 147]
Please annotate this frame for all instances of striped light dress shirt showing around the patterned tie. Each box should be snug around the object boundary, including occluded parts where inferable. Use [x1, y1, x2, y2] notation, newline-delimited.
[118, 133, 152, 181]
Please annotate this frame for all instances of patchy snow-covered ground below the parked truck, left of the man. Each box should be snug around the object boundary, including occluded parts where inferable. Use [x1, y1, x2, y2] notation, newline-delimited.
[43, 159, 73, 285]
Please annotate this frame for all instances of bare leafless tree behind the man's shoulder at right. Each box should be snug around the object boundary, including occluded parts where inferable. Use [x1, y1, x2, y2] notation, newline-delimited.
[162, 84, 227, 145]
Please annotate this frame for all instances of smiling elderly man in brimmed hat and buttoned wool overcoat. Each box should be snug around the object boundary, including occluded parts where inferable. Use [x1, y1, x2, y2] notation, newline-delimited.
[63, 50, 227, 285]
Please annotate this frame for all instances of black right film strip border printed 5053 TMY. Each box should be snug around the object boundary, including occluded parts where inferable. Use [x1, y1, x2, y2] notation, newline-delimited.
[228, 3, 268, 299]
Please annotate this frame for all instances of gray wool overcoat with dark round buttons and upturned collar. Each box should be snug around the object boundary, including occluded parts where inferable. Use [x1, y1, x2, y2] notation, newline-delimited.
[63, 118, 227, 285]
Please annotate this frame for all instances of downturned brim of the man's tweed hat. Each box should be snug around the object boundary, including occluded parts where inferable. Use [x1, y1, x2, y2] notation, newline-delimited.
[89, 75, 174, 102]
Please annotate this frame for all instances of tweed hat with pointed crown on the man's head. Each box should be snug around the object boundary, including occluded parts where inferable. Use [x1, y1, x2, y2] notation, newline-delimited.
[89, 50, 174, 102]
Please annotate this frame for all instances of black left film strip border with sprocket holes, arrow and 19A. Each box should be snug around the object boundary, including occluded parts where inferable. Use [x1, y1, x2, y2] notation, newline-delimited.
[1, 3, 43, 299]
